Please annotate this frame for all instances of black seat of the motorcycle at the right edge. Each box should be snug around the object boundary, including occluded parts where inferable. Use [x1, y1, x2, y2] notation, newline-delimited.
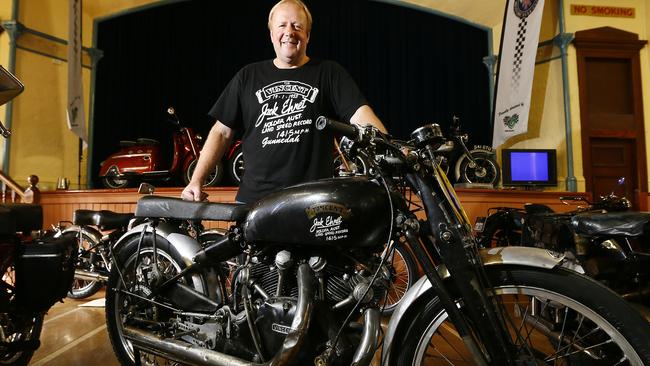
[571, 212, 650, 236]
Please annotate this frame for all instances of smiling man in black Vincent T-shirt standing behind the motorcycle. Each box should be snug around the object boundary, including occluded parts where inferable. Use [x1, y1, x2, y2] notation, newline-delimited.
[181, 0, 386, 203]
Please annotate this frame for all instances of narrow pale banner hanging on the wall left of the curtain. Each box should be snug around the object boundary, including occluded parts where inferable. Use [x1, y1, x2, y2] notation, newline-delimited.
[67, 0, 88, 148]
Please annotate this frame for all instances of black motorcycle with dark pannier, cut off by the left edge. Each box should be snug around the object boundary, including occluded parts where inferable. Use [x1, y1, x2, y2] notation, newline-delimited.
[0, 66, 77, 365]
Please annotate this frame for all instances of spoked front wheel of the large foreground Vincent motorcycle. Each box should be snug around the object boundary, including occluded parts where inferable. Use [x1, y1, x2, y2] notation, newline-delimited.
[390, 266, 650, 365]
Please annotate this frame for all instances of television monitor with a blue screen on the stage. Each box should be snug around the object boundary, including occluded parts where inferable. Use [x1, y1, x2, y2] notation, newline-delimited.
[501, 149, 557, 187]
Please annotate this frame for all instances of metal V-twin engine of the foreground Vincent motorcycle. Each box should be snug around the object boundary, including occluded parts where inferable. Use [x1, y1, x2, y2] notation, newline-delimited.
[243, 251, 390, 355]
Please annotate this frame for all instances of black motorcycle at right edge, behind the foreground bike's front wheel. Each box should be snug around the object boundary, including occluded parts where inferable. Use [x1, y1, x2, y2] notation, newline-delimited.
[477, 179, 650, 307]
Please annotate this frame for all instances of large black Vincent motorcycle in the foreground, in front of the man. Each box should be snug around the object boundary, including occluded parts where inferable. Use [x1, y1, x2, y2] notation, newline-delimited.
[106, 117, 650, 366]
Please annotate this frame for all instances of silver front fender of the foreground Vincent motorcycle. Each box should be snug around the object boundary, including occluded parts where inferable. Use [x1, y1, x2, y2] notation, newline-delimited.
[382, 247, 585, 365]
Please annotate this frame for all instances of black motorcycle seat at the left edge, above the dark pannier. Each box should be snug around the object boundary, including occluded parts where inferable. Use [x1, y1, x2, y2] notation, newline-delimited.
[0, 203, 43, 235]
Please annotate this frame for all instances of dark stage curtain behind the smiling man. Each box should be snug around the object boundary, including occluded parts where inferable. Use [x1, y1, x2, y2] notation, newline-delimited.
[92, 0, 491, 185]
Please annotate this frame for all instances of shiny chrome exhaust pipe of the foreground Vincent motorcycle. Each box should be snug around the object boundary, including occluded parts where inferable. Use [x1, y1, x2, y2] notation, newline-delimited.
[123, 264, 314, 366]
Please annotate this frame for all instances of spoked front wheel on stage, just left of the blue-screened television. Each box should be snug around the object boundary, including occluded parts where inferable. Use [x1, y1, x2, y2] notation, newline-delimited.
[456, 150, 501, 187]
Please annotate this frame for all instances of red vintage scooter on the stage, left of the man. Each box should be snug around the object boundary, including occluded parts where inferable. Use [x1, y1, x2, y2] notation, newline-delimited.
[99, 107, 224, 188]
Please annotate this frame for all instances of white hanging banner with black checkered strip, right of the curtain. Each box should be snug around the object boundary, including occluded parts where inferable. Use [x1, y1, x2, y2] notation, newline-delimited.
[492, 0, 544, 148]
